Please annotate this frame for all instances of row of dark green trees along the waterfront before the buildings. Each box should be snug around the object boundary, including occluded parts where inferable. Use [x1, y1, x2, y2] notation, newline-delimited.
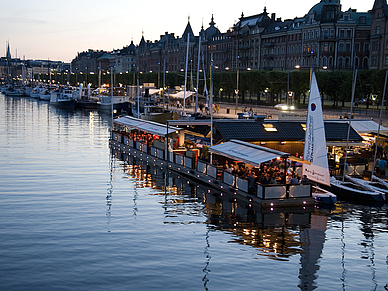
[41, 69, 385, 107]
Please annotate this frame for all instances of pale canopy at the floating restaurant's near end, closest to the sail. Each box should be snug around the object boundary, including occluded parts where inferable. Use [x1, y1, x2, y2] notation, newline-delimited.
[209, 139, 291, 166]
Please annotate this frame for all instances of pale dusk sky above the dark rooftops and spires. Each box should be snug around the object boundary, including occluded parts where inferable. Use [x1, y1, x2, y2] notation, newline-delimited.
[0, 0, 374, 62]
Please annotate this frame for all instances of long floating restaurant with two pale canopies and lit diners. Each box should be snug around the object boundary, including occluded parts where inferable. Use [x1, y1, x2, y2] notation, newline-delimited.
[110, 116, 314, 210]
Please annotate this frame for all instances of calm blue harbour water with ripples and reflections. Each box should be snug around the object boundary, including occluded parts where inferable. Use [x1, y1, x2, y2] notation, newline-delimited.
[0, 94, 388, 290]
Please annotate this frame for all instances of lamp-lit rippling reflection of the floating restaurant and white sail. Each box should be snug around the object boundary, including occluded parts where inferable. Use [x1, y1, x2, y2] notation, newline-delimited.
[110, 152, 327, 290]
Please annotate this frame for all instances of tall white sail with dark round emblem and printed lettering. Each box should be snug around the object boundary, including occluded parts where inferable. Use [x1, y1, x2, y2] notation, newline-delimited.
[303, 71, 330, 186]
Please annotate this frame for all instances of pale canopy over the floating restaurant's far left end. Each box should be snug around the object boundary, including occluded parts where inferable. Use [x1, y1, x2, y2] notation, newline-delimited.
[113, 116, 182, 136]
